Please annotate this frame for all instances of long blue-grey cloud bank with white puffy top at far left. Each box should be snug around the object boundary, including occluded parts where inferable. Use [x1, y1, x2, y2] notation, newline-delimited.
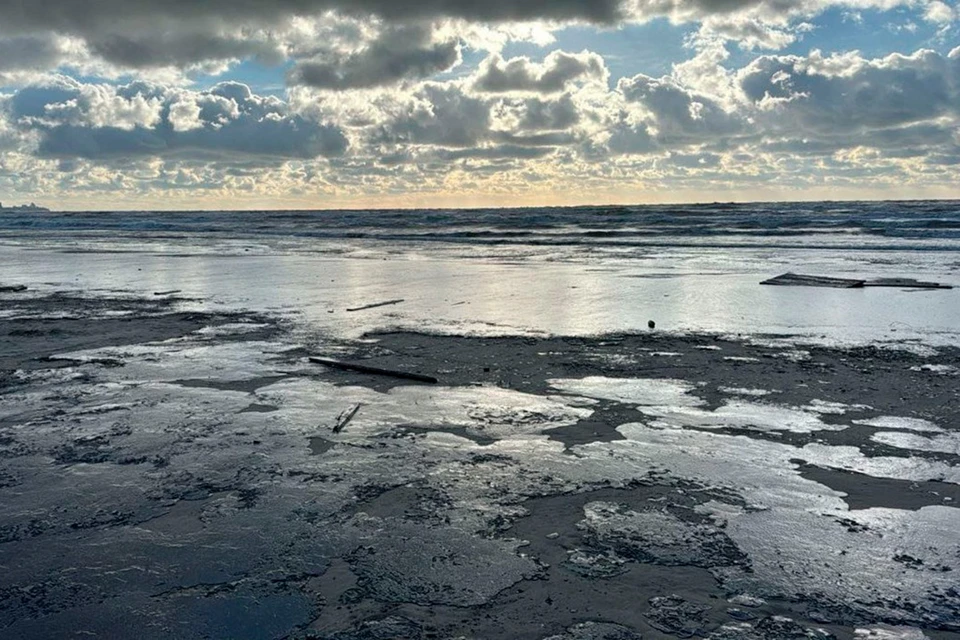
[6, 79, 348, 162]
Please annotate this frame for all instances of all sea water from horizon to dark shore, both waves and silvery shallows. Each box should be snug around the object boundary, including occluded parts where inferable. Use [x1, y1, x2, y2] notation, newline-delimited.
[0, 201, 960, 345]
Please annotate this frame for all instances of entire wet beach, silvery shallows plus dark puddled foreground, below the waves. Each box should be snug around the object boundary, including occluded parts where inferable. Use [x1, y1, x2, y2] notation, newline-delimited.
[0, 206, 960, 640]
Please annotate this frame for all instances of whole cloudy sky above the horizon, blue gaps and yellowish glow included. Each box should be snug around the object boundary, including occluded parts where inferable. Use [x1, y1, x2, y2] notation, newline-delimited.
[0, 0, 960, 210]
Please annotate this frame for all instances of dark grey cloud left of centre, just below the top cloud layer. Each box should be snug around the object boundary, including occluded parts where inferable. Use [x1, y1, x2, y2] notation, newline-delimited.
[287, 25, 460, 90]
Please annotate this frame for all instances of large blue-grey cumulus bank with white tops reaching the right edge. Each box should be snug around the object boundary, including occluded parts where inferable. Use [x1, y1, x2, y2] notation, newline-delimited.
[592, 43, 960, 164]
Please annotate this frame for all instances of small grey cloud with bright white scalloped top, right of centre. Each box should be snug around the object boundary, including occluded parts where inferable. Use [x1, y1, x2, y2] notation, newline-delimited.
[473, 50, 609, 93]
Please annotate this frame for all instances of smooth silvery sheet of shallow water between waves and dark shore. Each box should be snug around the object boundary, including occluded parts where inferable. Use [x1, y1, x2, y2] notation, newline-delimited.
[0, 246, 960, 345]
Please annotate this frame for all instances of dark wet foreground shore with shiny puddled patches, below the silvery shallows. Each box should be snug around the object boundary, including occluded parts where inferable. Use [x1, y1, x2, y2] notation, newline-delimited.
[0, 292, 960, 640]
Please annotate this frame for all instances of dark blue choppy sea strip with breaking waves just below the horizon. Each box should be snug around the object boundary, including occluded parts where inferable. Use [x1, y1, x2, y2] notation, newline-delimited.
[0, 201, 960, 259]
